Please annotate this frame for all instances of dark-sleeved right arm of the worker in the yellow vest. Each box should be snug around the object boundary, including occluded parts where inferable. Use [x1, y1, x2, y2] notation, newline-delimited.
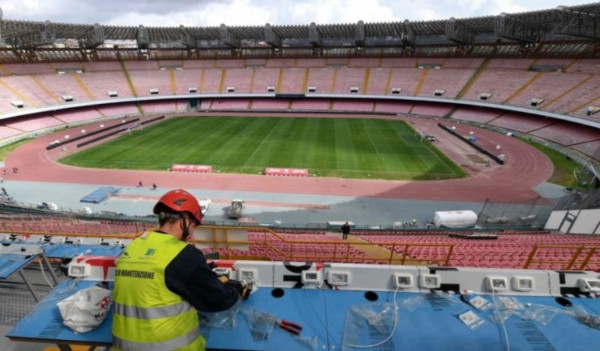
[165, 245, 240, 312]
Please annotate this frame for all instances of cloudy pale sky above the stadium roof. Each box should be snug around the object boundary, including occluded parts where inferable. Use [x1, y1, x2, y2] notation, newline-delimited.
[0, 0, 594, 27]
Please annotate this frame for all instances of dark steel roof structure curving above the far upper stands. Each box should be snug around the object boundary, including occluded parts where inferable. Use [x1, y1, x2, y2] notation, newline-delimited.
[0, 3, 600, 62]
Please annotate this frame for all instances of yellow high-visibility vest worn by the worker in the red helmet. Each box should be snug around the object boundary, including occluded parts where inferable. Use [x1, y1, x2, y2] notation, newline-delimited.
[112, 232, 206, 351]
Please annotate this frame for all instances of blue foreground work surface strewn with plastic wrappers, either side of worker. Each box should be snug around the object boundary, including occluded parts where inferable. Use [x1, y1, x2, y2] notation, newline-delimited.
[7, 280, 600, 351]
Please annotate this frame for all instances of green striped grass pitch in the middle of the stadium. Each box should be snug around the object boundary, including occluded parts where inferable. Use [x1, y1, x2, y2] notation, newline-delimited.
[60, 117, 465, 180]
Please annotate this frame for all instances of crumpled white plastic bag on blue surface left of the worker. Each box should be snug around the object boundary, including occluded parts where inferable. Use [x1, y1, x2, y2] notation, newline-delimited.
[57, 285, 112, 333]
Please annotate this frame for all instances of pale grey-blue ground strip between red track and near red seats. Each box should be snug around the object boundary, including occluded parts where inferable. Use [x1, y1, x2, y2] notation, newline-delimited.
[4, 180, 492, 226]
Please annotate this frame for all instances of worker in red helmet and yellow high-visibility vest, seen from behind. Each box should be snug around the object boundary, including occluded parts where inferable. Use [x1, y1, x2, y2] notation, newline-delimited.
[112, 189, 249, 351]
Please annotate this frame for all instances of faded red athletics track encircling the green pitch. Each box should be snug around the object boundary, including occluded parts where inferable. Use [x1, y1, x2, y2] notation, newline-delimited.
[5, 113, 553, 202]
